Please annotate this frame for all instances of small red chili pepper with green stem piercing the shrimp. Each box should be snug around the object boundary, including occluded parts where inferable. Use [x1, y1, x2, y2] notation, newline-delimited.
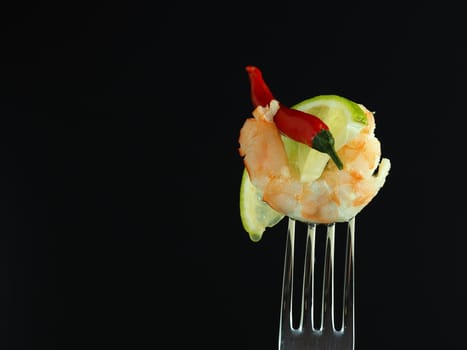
[246, 66, 343, 169]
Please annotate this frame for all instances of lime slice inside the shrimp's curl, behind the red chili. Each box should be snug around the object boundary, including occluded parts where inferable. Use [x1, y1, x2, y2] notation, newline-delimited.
[283, 95, 368, 182]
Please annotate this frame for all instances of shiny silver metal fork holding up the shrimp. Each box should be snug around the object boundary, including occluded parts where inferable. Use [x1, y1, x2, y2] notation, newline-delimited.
[279, 218, 355, 350]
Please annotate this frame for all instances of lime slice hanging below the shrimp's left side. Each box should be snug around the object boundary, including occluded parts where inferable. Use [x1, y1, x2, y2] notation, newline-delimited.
[240, 169, 284, 242]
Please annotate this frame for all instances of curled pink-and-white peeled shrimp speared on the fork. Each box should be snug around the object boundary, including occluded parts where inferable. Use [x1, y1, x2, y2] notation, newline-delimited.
[239, 100, 391, 223]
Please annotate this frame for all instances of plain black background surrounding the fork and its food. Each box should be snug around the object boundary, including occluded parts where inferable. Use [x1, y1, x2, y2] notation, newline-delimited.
[0, 1, 466, 350]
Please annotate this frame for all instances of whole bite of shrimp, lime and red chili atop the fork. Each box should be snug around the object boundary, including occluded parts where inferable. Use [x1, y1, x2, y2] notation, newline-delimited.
[239, 66, 391, 241]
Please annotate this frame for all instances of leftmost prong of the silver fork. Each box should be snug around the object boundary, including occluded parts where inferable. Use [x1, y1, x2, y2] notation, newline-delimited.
[279, 218, 295, 339]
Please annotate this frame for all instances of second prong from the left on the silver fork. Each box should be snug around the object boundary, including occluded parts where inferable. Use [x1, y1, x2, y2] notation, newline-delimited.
[300, 223, 316, 330]
